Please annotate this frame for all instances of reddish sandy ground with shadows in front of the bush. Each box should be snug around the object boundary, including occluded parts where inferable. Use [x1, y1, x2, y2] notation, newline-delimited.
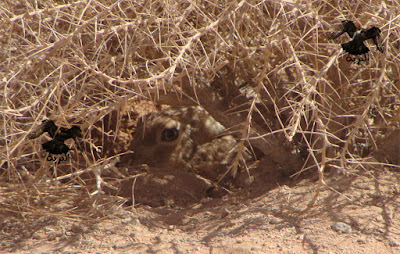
[0, 164, 400, 253]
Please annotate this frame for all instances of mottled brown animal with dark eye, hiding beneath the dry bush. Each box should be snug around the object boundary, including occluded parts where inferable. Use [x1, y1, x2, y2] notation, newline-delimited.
[130, 106, 236, 181]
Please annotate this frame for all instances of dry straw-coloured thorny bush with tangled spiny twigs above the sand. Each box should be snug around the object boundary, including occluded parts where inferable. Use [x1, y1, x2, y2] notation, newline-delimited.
[0, 0, 400, 217]
